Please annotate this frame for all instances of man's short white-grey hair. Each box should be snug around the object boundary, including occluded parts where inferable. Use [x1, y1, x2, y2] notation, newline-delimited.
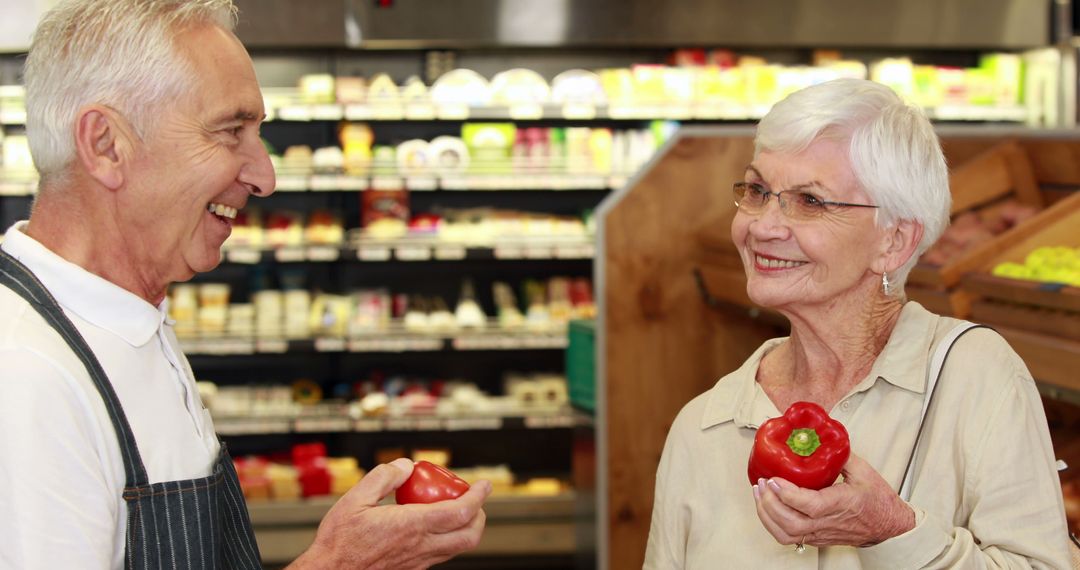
[24, 0, 237, 181]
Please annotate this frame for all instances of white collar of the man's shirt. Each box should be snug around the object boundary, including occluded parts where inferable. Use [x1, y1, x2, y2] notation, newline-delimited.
[2, 221, 167, 347]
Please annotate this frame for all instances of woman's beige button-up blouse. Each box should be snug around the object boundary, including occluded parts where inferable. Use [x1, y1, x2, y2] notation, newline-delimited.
[645, 302, 1069, 569]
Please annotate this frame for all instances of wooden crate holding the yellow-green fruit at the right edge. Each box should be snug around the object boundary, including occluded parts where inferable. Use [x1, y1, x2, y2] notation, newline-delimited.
[961, 192, 1080, 394]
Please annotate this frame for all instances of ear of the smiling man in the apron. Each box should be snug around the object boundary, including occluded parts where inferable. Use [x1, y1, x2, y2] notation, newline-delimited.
[75, 105, 129, 190]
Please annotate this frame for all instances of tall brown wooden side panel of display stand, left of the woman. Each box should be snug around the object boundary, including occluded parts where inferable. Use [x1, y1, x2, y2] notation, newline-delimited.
[595, 128, 781, 569]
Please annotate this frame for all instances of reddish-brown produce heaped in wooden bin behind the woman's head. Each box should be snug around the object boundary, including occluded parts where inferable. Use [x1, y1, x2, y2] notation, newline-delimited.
[919, 200, 1039, 266]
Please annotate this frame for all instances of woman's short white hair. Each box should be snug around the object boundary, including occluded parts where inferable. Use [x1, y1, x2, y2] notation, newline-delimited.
[754, 79, 951, 296]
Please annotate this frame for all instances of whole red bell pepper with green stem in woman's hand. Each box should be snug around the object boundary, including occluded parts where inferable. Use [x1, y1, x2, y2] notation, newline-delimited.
[747, 402, 851, 490]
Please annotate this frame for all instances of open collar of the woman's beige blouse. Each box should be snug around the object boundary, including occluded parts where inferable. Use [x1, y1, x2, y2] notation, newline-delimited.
[701, 302, 937, 430]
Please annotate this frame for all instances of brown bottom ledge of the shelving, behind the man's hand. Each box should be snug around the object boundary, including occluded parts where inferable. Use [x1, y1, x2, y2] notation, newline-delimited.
[248, 491, 577, 564]
